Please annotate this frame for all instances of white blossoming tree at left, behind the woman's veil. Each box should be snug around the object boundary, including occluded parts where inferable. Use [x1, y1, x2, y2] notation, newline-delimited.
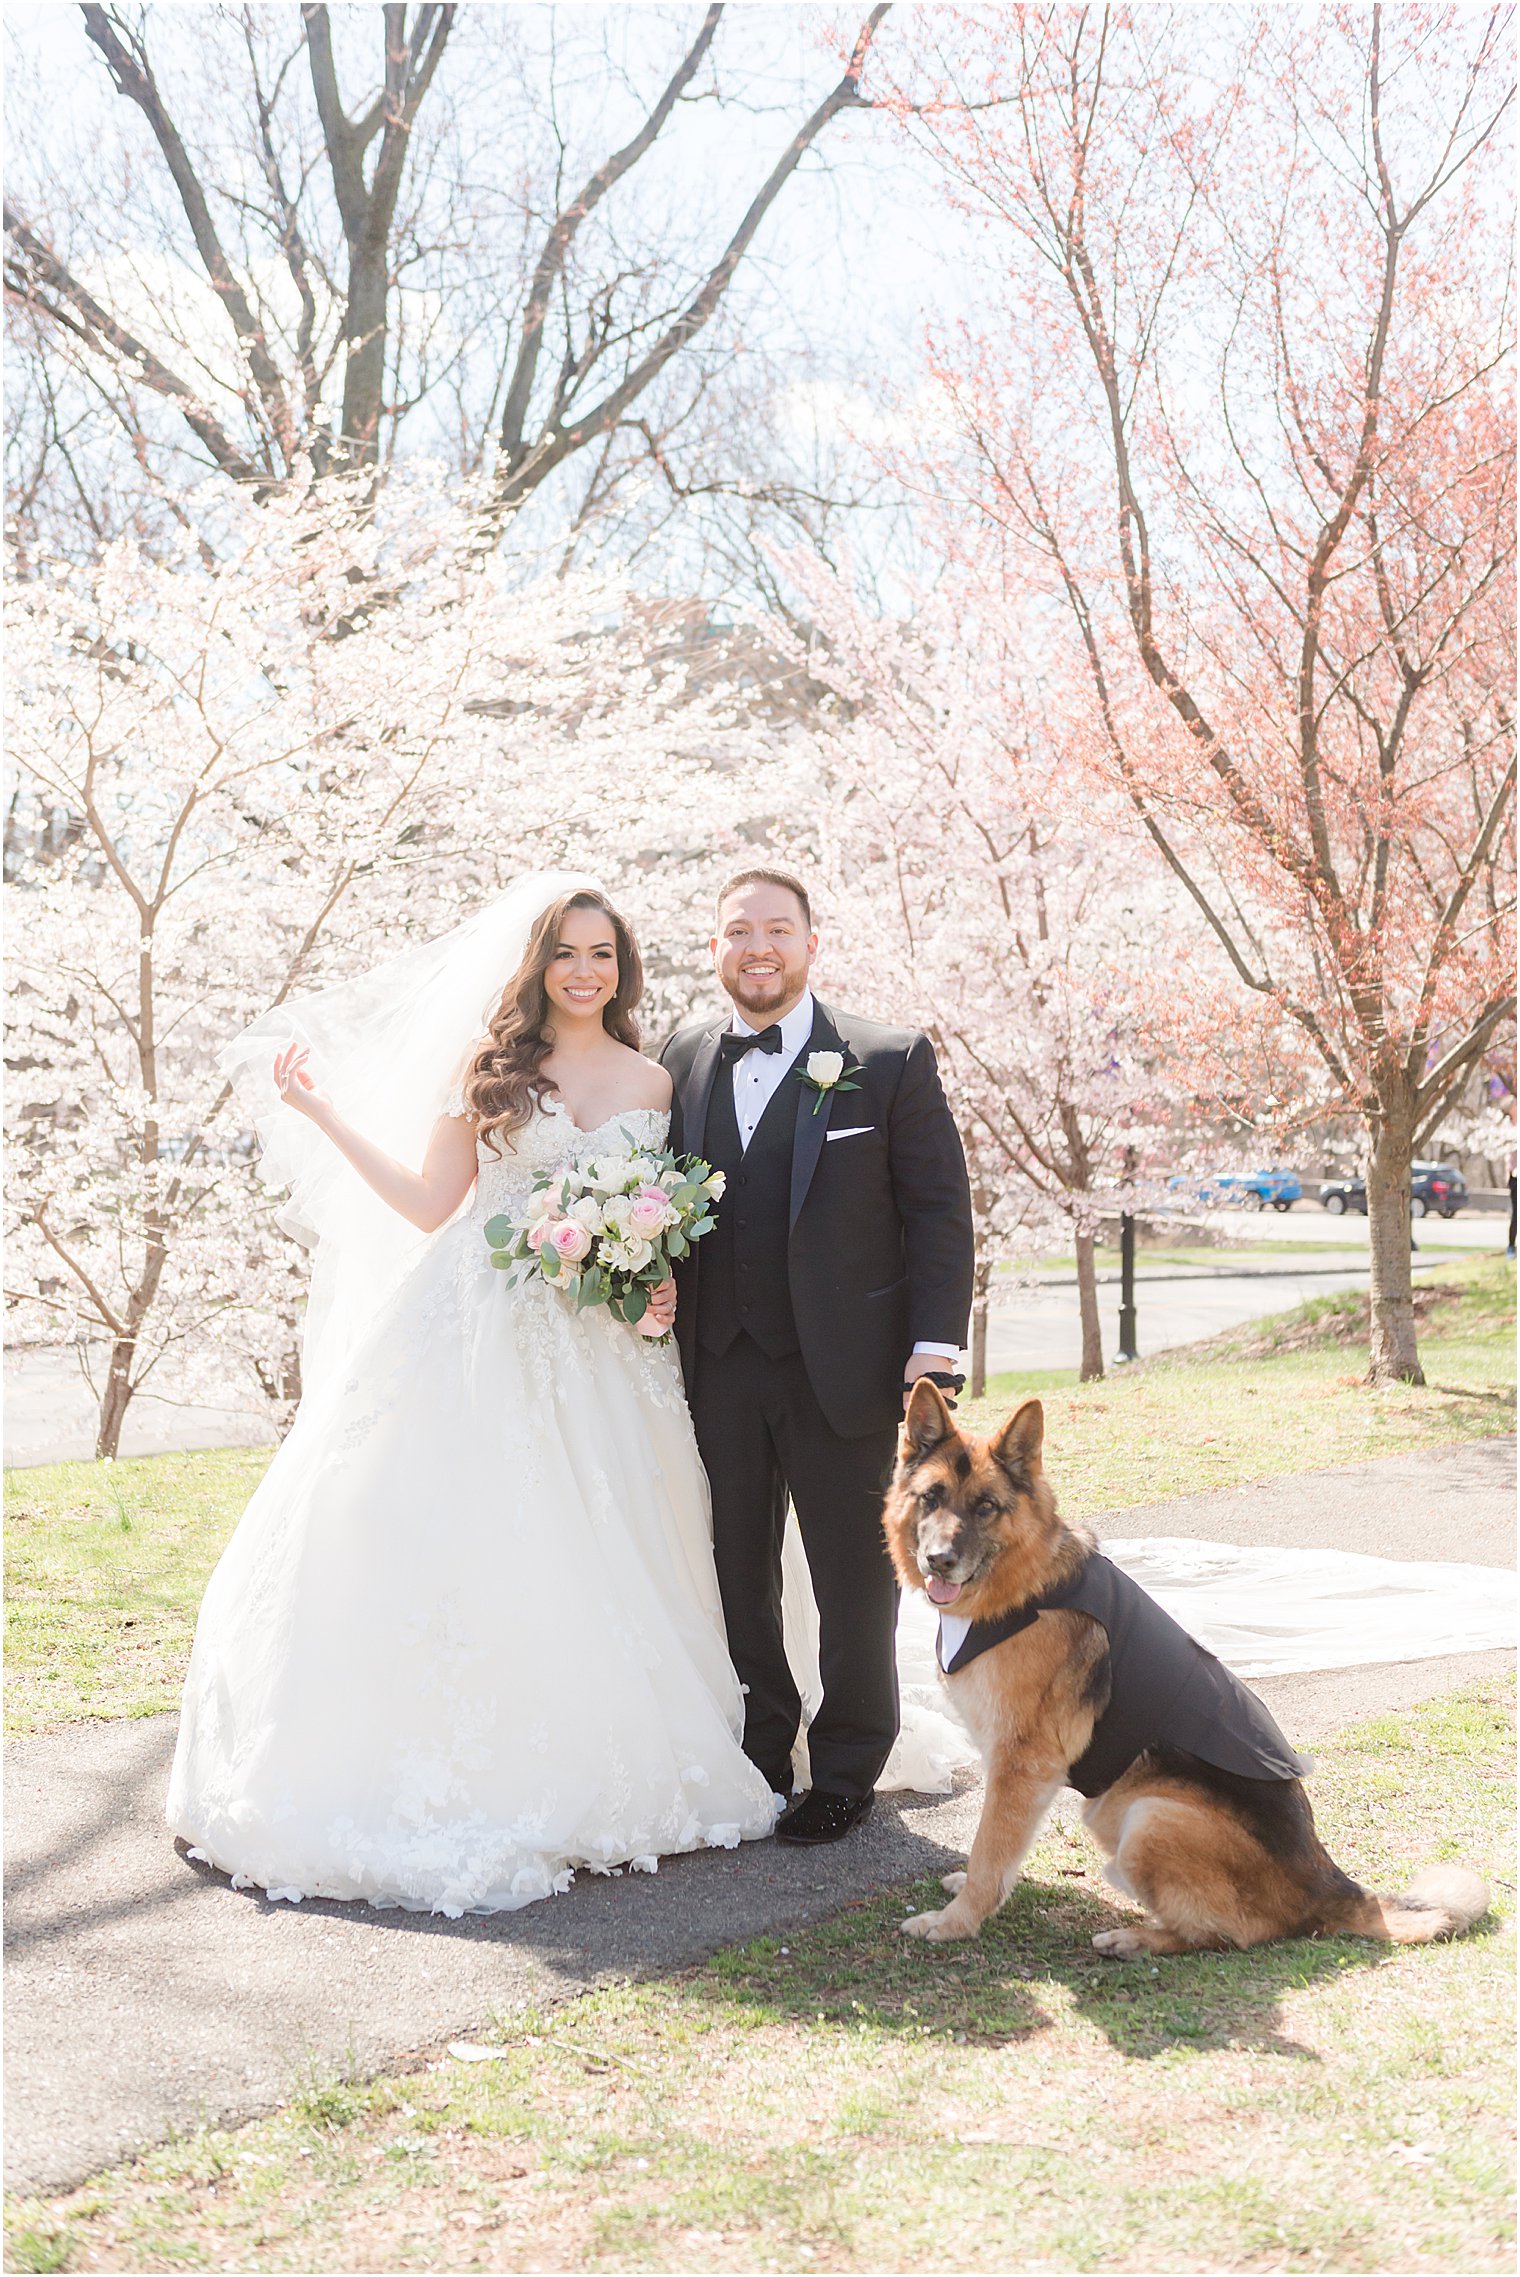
[7, 478, 794, 1455]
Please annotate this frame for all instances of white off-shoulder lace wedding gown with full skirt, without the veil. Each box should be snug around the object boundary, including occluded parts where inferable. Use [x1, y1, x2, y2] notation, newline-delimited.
[168, 1098, 774, 1915]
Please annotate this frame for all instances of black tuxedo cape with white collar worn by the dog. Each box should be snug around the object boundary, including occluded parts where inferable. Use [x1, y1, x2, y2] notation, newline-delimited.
[935, 1557, 1311, 1797]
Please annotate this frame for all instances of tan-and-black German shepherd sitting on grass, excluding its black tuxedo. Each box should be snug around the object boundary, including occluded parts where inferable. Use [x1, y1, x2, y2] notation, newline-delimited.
[883, 1382, 1488, 1960]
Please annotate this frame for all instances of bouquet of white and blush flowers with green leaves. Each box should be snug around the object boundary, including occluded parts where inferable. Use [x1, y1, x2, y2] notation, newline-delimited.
[485, 1132, 724, 1337]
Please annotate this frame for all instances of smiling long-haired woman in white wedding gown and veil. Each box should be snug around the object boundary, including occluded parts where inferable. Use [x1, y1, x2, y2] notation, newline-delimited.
[168, 877, 776, 1915]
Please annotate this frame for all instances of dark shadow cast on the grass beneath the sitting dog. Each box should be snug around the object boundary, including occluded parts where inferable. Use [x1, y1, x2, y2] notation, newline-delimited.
[683, 1881, 1447, 2063]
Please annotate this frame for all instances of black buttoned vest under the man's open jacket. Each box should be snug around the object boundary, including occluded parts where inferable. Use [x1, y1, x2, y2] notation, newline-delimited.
[696, 1068, 803, 1359]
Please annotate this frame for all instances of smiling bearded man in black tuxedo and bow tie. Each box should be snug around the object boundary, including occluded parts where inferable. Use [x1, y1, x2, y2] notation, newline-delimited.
[660, 870, 972, 1842]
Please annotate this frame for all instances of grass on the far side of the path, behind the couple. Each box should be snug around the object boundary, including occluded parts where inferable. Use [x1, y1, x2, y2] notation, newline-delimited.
[5, 1257, 1515, 1733]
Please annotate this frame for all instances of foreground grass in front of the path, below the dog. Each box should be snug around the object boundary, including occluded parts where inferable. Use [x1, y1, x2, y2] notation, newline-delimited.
[7, 1685, 1513, 2272]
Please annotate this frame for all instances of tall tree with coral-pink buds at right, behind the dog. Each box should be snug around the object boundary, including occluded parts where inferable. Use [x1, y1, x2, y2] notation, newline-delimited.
[881, 7, 1515, 1380]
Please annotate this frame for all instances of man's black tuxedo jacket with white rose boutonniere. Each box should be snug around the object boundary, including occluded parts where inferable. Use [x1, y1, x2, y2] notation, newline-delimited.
[660, 1004, 976, 1439]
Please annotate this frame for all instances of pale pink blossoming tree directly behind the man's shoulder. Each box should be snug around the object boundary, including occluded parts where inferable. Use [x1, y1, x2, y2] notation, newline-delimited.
[785, 553, 1183, 1389]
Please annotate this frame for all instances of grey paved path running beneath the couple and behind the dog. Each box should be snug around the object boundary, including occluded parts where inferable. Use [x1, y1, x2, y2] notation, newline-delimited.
[5, 1439, 1513, 2190]
